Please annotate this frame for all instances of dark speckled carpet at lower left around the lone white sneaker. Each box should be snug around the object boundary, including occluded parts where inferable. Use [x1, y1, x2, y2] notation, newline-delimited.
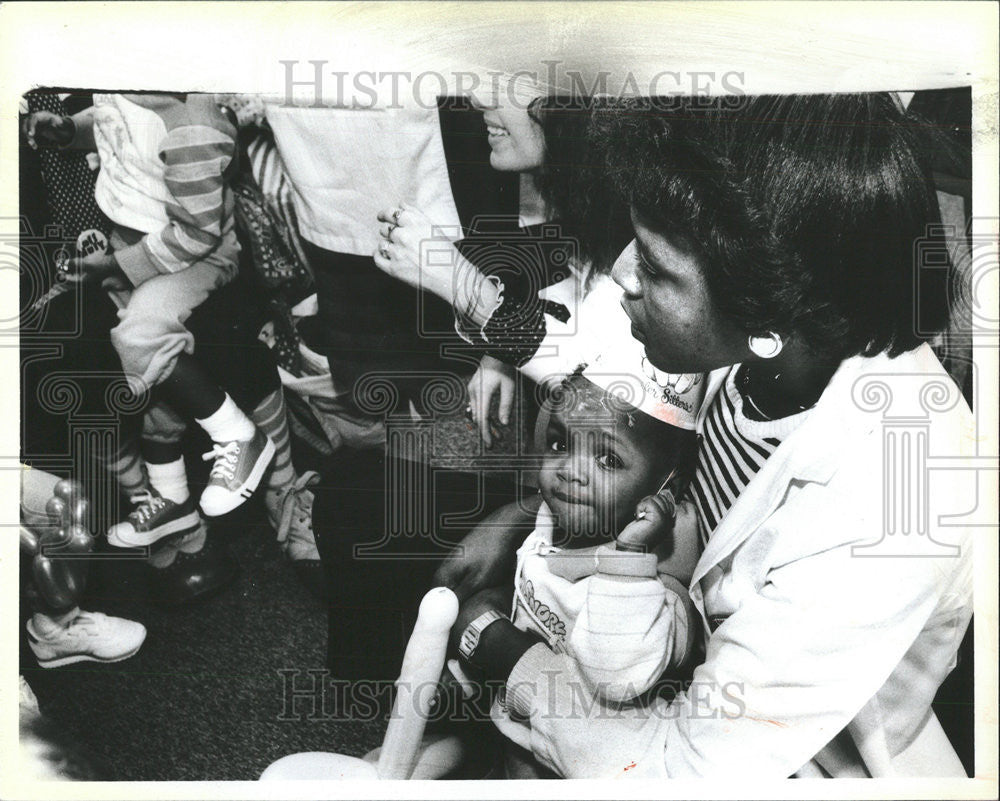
[21, 482, 383, 780]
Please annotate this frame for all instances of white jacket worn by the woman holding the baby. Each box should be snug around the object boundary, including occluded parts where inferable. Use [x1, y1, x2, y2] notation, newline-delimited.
[507, 346, 972, 778]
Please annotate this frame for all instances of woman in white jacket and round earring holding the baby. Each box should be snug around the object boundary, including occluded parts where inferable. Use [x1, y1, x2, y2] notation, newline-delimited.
[439, 94, 976, 778]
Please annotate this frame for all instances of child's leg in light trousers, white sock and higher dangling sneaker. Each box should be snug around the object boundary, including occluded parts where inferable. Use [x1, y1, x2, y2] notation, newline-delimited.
[111, 263, 274, 517]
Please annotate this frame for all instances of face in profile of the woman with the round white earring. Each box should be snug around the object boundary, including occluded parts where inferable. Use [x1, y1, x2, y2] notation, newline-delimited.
[611, 212, 747, 373]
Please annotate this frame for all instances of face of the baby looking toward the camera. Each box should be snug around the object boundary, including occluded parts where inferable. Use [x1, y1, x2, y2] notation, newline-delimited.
[538, 412, 661, 548]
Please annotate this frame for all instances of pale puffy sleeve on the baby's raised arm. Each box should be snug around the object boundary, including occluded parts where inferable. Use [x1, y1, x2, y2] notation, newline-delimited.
[567, 546, 698, 702]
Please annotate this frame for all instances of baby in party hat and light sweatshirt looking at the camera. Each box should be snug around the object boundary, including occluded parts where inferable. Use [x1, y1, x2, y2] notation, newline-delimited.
[422, 366, 704, 778]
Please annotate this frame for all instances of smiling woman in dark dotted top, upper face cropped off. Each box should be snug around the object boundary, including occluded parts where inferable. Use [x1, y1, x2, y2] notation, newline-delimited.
[374, 90, 644, 445]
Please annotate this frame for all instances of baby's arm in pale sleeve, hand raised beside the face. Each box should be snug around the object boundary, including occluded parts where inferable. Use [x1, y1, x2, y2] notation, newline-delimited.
[568, 496, 698, 702]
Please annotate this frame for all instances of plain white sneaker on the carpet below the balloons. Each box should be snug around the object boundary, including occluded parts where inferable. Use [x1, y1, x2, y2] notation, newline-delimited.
[28, 612, 146, 668]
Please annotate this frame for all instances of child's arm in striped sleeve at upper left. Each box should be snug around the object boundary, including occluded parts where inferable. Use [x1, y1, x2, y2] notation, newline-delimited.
[115, 109, 236, 286]
